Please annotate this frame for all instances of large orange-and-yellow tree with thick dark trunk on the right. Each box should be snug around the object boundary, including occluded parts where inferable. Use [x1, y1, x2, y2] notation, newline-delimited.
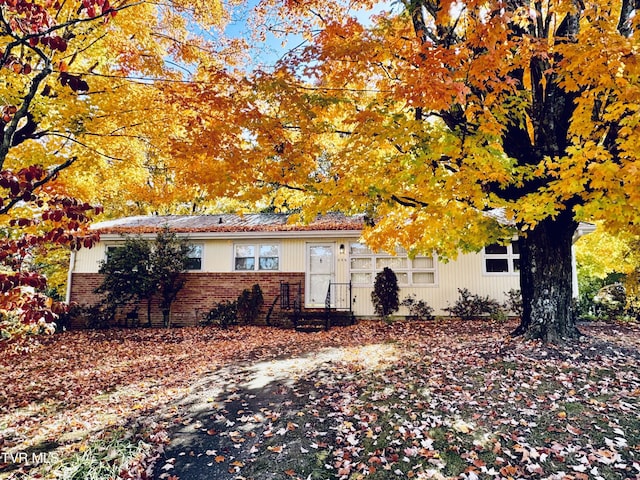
[164, 0, 640, 340]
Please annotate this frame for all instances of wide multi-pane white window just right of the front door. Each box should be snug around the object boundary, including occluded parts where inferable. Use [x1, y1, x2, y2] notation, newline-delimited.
[349, 243, 436, 286]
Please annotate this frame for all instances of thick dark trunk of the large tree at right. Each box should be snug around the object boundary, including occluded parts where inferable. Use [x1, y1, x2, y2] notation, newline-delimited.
[512, 212, 580, 343]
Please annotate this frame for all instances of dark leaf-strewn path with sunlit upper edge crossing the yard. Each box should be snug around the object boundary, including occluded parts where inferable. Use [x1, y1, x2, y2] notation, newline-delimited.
[154, 345, 394, 480]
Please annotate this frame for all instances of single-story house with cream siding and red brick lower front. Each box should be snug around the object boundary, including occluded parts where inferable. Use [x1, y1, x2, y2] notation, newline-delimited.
[67, 213, 596, 324]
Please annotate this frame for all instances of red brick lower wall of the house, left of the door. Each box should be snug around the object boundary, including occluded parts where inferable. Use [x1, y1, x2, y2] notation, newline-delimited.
[70, 272, 304, 328]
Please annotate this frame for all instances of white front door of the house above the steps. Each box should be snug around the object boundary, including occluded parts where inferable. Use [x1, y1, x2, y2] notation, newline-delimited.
[306, 243, 335, 307]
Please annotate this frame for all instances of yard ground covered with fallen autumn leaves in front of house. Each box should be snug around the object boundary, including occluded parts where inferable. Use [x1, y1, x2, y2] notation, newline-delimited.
[0, 321, 640, 480]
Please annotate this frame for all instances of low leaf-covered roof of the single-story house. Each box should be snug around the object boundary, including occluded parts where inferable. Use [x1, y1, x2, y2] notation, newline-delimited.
[92, 213, 364, 234]
